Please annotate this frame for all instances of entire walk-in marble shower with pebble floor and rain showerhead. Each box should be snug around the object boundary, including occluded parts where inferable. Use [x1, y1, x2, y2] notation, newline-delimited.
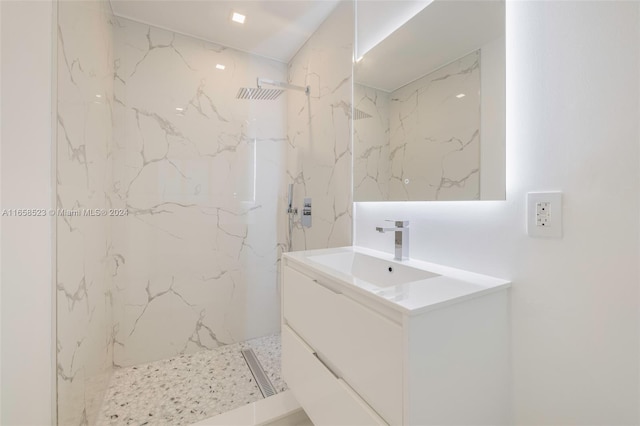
[54, 0, 353, 426]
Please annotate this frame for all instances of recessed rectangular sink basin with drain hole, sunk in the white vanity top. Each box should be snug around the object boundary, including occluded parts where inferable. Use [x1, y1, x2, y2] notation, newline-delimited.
[308, 251, 439, 288]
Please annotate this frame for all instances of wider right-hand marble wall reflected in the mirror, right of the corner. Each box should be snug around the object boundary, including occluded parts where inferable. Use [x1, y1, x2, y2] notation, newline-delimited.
[389, 50, 480, 201]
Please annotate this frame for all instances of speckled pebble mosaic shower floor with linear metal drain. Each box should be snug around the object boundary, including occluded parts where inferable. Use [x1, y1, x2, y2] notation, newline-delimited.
[97, 334, 287, 426]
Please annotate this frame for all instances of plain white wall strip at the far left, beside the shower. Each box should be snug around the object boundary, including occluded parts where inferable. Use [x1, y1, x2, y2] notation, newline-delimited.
[0, 1, 54, 425]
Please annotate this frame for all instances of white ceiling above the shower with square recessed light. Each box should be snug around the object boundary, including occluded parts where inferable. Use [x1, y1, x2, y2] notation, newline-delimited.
[110, 0, 339, 63]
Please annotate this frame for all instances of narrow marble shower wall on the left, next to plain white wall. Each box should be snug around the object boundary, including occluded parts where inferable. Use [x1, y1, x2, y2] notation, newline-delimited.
[56, 1, 114, 425]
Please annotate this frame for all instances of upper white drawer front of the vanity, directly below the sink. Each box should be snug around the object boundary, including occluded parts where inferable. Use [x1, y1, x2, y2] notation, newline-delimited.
[283, 266, 402, 425]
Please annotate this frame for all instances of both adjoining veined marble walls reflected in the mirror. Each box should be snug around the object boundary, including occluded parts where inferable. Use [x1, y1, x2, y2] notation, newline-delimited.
[354, 50, 481, 201]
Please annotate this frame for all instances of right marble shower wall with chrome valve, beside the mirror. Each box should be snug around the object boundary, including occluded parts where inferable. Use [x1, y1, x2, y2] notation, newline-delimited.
[280, 1, 354, 250]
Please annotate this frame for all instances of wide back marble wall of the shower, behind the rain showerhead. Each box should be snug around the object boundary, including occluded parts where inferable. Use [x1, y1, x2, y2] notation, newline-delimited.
[112, 18, 287, 366]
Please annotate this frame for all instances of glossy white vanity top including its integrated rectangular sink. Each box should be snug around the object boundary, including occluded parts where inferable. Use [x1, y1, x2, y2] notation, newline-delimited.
[284, 246, 511, 315]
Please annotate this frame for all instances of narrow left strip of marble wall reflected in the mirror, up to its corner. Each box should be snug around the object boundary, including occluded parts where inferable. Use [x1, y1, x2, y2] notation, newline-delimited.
[353, 83, 391, 201]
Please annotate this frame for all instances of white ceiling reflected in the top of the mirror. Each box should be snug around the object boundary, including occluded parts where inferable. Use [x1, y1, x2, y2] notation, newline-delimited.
[355, 0, 505, 92]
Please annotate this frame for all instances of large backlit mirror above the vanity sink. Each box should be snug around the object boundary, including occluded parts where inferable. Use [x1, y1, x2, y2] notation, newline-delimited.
[352, 0, 505, 201]
